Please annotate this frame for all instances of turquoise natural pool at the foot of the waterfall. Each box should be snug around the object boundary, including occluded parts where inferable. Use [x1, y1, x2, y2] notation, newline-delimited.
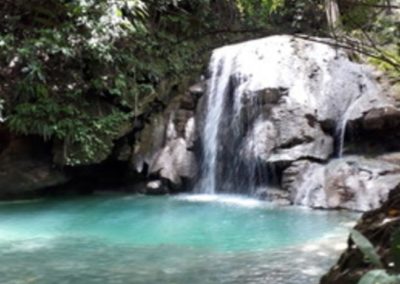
[0, 195, 356, 284]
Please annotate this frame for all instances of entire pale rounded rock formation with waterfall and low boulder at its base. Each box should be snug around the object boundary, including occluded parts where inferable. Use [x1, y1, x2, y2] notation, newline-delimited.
[192, 36, 400, 211]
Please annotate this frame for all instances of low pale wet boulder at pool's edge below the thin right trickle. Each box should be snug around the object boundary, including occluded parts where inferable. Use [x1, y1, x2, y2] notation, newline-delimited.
[283, 157, 400, 211]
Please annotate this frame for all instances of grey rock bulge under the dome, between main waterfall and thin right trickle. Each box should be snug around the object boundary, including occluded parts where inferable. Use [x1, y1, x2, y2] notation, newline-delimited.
[242, 97, 334, 164]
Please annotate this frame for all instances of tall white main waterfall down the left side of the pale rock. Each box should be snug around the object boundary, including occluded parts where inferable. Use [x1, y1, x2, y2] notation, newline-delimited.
[196, 46, 268, 194]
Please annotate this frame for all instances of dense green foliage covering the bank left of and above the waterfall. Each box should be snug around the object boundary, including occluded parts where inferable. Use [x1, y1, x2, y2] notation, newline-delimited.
[0, 0, 400, 165]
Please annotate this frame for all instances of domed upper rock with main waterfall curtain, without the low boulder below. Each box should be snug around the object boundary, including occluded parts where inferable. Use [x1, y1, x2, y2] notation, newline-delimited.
[196, 36, 387, 200]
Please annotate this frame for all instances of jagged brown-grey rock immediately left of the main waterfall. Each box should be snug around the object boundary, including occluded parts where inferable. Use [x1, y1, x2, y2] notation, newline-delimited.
[131, 85, 204, 194]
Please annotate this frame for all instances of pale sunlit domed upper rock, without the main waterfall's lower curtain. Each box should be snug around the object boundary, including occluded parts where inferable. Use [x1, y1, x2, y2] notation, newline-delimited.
[203, 36, 396, 176]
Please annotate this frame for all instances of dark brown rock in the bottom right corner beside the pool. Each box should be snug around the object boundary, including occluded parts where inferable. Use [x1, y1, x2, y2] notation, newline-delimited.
[320, 187, 400, 284]
